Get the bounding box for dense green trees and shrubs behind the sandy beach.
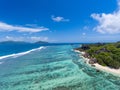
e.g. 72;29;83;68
77;42;120;69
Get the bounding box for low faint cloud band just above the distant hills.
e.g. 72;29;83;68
4;36;48;42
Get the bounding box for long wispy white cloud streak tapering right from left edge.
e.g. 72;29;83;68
0;22;49;33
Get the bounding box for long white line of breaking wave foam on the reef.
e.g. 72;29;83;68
0;46;45;60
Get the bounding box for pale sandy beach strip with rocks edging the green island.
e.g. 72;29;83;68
74;50;120;76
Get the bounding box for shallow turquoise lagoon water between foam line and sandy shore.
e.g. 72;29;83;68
0;45;120;90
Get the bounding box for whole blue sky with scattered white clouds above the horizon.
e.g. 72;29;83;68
0;0;120;43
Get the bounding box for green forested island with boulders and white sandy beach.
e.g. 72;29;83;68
75;42;120;74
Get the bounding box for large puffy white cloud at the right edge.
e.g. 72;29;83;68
91;0;120;34
